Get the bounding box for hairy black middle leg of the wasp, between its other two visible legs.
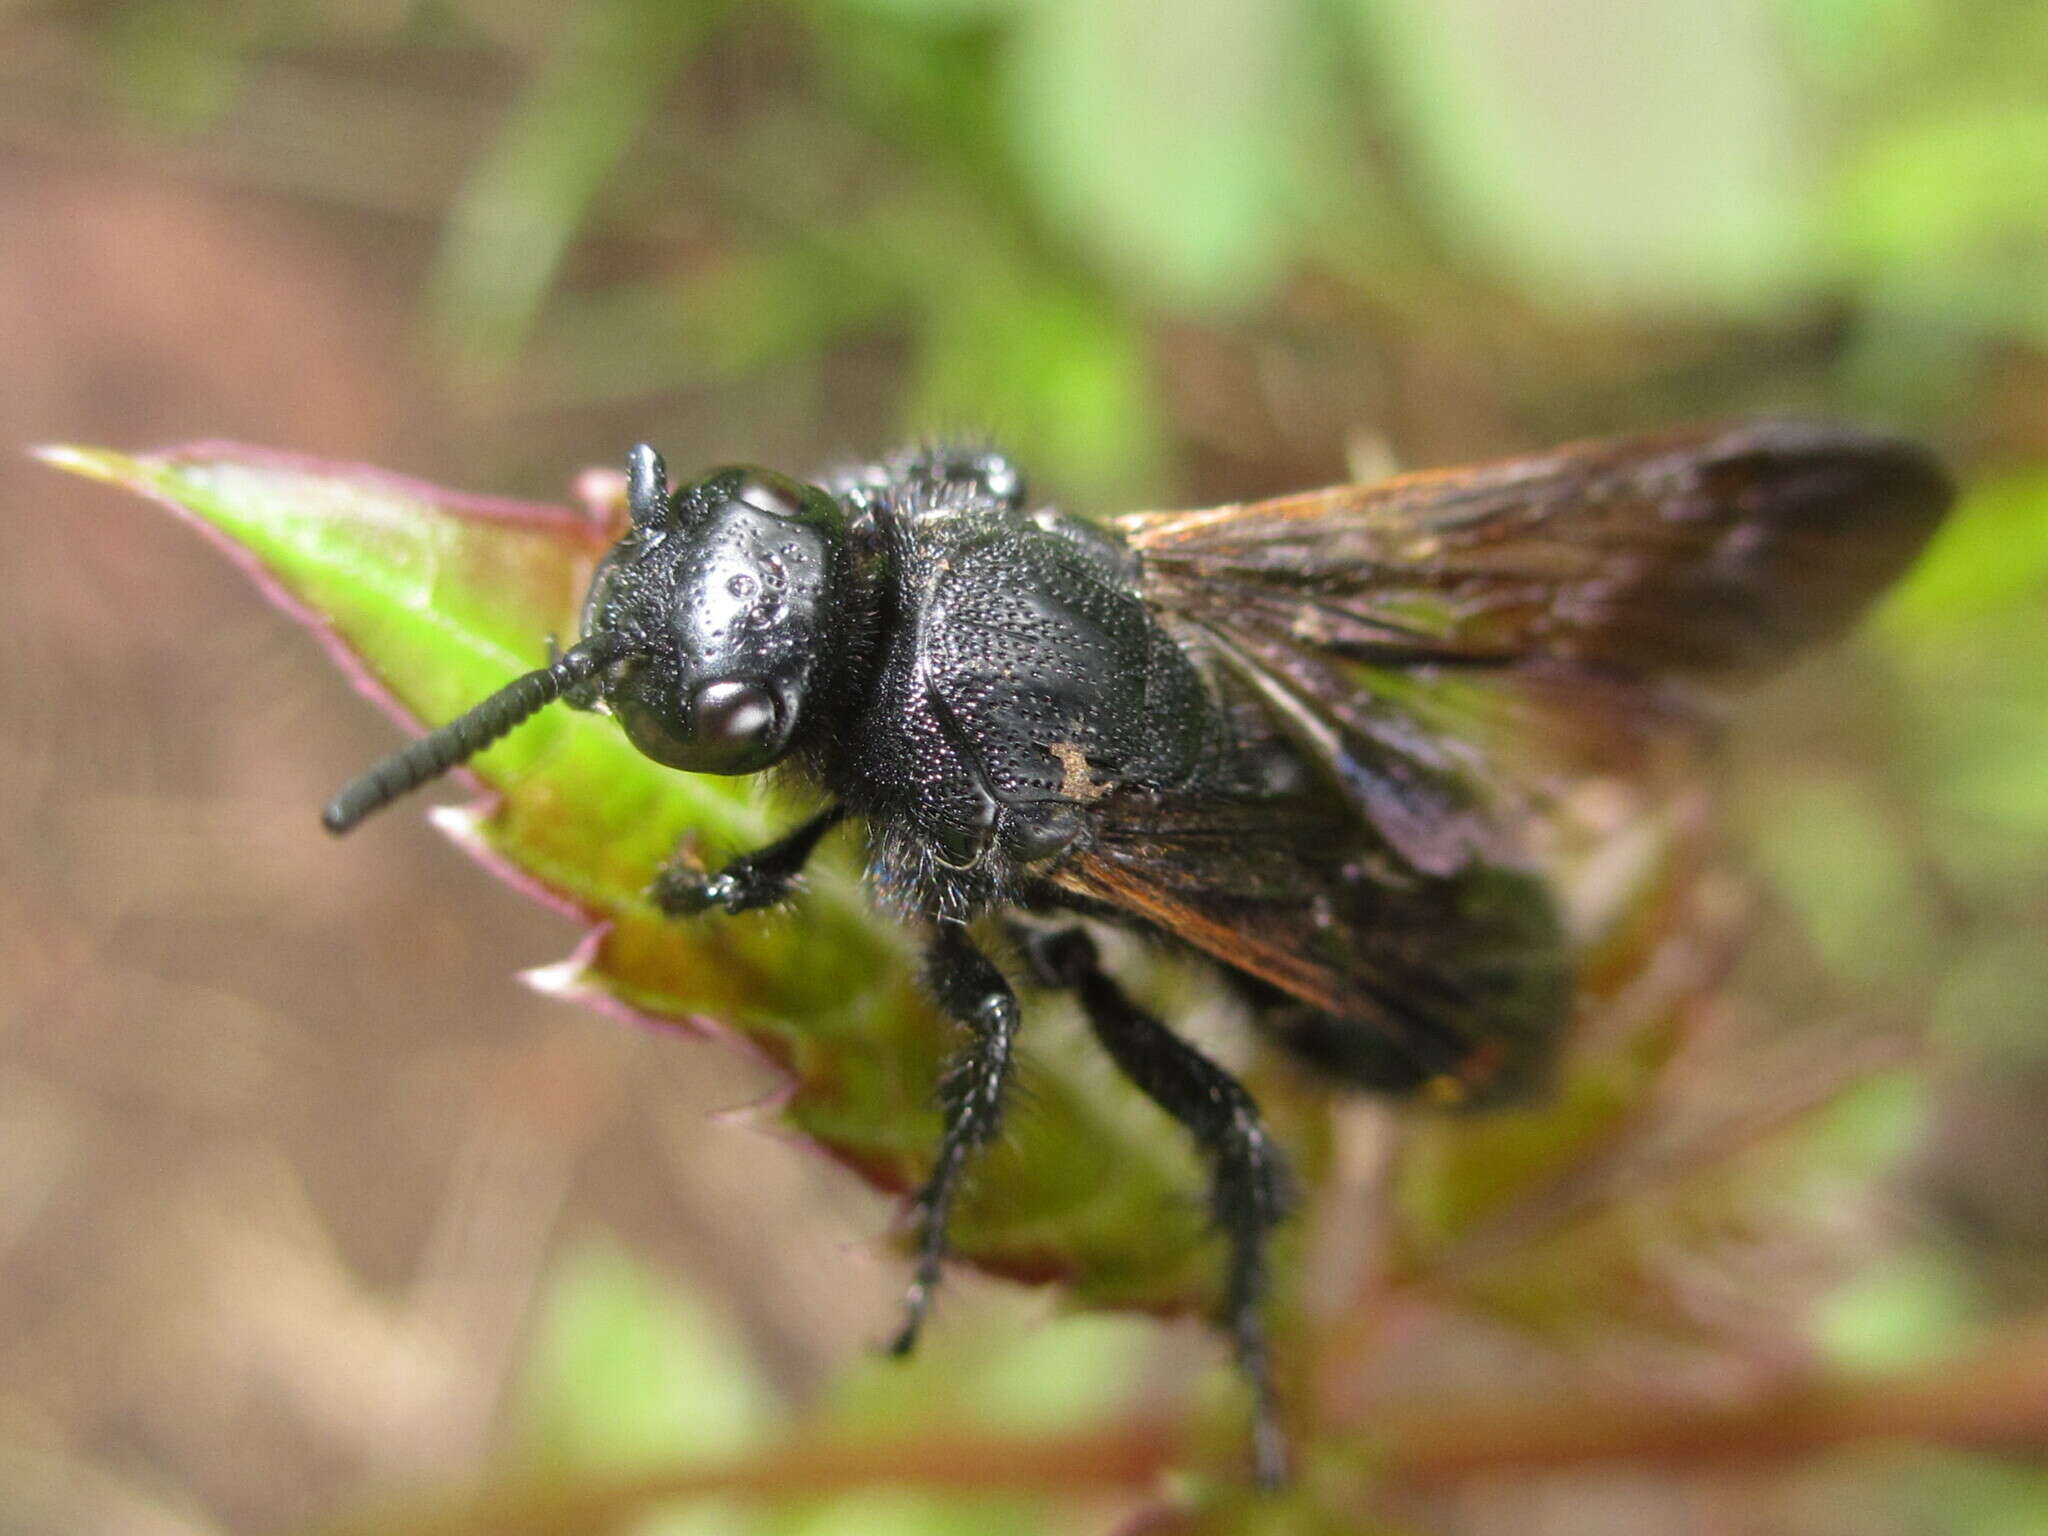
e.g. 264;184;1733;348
889;924;1018;1356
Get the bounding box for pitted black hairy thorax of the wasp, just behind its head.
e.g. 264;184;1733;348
819;487;1223;915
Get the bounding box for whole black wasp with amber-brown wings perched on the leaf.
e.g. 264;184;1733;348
326;422;1950;1479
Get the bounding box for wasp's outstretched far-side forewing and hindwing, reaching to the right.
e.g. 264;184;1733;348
1120;422;1950;874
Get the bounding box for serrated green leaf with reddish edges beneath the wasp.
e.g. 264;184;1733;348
43;444;1277;1307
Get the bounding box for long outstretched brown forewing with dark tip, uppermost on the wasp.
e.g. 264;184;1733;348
1118;422;1952;674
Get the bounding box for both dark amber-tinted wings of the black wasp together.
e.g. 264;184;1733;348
1055;422;1950;1100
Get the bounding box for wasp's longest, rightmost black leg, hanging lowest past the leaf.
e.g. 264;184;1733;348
1024;928;1294;1487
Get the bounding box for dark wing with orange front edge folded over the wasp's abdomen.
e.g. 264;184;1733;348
1053;786;1573;1106
